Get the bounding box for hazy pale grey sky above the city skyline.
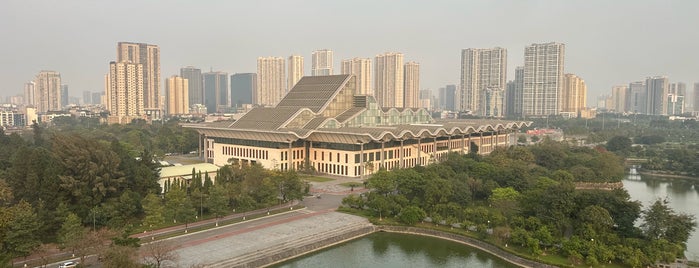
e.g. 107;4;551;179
0;0;699;106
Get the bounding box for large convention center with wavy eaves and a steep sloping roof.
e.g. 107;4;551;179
184;75;530;177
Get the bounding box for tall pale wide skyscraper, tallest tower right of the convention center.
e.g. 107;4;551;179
522;43;565;116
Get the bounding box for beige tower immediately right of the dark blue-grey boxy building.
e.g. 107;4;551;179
255;57;287;106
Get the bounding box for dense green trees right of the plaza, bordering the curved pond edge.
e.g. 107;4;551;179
343;140;696;267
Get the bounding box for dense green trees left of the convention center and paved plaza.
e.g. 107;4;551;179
0;118;307;267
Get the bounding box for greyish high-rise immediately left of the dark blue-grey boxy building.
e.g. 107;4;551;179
203;72;231;113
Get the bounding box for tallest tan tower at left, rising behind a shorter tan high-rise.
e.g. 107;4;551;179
116;42;162;109
